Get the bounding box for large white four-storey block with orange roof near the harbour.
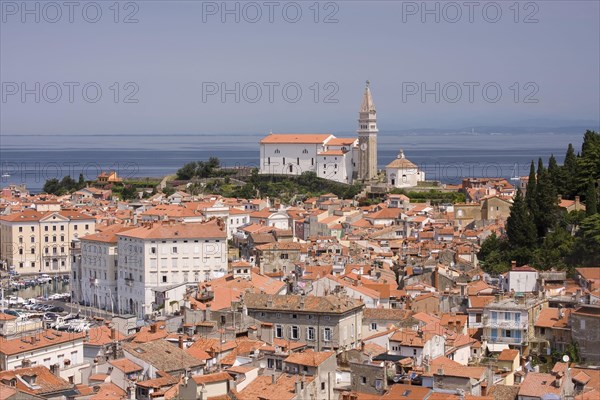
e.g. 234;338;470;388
117;219;227;317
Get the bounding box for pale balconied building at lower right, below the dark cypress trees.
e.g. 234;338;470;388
482;296;548;354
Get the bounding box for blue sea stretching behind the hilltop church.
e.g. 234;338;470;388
0;129;584;193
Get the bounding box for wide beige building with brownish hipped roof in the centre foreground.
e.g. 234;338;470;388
243;293;364;352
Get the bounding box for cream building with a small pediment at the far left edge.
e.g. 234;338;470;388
0;208;96;275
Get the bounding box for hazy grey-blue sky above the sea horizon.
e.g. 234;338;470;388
0;0;600;135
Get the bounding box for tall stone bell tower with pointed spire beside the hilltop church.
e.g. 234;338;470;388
356;81;379;181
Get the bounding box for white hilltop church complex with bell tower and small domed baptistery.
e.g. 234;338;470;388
259;81;425;187
